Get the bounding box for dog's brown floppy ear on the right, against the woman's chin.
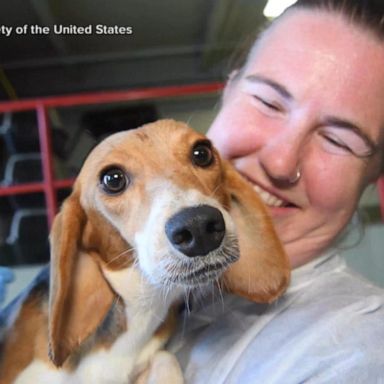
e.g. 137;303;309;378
223;162;290;303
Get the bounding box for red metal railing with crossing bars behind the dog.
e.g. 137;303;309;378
0;82;223;227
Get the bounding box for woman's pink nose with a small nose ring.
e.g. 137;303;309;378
258;134;304;184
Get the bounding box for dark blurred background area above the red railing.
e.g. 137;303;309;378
0;0;266;99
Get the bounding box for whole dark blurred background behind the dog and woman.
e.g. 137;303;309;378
0;0;384;306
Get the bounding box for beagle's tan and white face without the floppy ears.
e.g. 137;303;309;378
76;121;239;286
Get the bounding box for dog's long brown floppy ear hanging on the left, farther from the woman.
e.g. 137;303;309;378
49;192;114;366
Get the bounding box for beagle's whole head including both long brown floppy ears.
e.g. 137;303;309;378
49;120;289;365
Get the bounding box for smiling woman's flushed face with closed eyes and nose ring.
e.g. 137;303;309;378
208;10;384;267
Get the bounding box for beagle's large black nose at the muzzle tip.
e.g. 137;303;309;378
165;205;225;257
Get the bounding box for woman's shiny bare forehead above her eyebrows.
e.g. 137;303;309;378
243;10;384;141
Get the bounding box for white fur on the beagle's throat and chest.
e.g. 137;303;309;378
15;267;180;384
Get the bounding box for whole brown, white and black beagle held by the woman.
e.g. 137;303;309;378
0;120;290;384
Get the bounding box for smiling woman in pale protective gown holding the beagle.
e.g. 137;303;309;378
171;0;384;384
